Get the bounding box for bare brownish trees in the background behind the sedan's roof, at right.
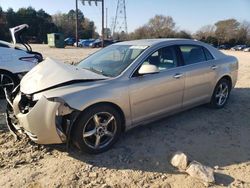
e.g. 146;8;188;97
125;15;250;46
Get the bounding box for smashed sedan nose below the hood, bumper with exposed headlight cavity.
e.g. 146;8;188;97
6;88;79;144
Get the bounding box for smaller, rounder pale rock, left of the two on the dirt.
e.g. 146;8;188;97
171;152;188;171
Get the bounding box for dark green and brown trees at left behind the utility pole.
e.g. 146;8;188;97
0;7;98;43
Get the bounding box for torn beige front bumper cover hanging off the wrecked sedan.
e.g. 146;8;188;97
6;93;63;144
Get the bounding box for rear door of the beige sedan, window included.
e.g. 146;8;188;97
179;45;216;108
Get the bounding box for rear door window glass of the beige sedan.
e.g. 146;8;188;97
180;45;206;65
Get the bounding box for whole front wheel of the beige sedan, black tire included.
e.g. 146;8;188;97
72;105;122;154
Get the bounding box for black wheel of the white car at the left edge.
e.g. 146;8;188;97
0;70;20;98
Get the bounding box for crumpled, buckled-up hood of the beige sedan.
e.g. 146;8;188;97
20;58;107;94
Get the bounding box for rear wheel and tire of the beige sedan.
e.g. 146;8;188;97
210;78;231;109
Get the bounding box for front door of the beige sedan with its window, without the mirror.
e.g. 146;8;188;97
129;46;185;124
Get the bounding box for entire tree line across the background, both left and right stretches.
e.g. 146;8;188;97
0;7;250;46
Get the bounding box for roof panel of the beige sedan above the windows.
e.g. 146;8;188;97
116;38;195;46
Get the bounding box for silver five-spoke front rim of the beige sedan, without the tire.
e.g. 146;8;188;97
83;112;117;149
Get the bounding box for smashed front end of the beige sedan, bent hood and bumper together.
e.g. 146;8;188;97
5;59;109;144
